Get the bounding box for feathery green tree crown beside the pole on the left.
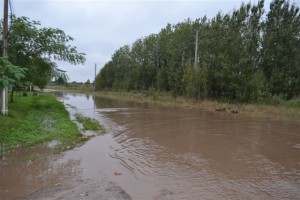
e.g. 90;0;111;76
0;16;85;92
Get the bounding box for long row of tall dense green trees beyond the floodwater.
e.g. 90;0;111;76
96;0;300;102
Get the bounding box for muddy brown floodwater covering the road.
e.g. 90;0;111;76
0;94;300;200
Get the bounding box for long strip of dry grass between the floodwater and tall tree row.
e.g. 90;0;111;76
45;90;300;121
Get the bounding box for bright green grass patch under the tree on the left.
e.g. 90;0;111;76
0;93;82;151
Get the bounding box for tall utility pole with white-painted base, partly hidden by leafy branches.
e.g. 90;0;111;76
1;0;8;115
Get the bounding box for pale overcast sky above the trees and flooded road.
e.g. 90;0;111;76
1;0;286;82
